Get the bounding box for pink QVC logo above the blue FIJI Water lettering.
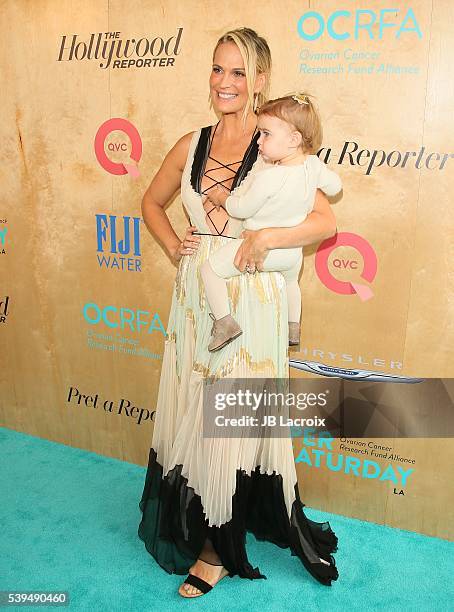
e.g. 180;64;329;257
94;117;142;178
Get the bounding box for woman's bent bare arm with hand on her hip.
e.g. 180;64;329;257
141;132;197;261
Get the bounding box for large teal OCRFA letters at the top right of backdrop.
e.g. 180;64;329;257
297;8;422;41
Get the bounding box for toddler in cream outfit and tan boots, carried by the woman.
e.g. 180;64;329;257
201;94;342;351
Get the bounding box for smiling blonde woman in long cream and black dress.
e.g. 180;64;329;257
139;28;337;597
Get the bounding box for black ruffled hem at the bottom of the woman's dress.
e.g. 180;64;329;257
138;448;338;585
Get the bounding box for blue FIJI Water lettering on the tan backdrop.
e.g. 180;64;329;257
95;214;143;272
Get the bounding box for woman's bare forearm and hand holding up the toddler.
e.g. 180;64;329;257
234;189;336;272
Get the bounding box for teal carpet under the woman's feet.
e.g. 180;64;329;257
0;428;454;612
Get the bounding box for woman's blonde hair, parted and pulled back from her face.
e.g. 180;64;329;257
210;28;271;123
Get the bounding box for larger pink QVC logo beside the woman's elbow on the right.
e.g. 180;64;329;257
315;232;377;302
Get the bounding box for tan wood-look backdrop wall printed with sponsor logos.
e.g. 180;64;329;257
0;0;454;539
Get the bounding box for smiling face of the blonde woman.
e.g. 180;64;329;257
210;41;252;114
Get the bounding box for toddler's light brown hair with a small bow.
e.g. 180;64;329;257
257;93;323;154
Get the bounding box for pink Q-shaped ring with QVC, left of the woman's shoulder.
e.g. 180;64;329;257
95;118;142;178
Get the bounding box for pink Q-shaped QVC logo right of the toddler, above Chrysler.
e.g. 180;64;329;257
315;232;377;302
